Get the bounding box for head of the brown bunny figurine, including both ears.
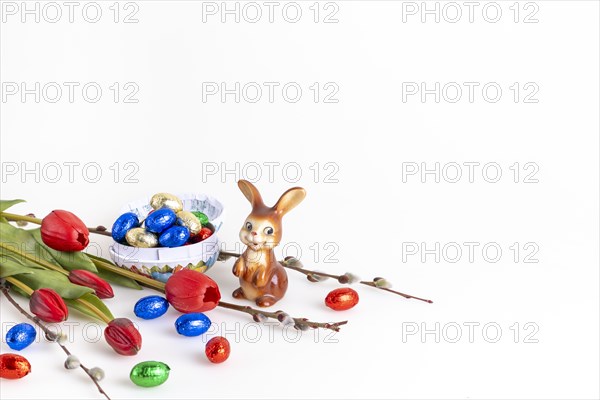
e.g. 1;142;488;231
238;180;306;251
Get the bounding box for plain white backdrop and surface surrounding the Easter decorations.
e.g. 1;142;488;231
0;1;600;399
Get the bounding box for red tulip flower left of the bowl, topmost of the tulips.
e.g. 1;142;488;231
41;210;90;251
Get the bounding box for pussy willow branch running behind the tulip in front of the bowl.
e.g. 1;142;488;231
88;254;348;332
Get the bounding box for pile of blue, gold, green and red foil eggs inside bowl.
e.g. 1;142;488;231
112;193;213;247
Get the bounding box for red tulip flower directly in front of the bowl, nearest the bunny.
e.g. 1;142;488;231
165;268;221;313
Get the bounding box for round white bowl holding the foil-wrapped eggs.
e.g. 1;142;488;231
109;193;223;282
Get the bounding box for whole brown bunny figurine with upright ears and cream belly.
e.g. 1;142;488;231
233;180;306;307
